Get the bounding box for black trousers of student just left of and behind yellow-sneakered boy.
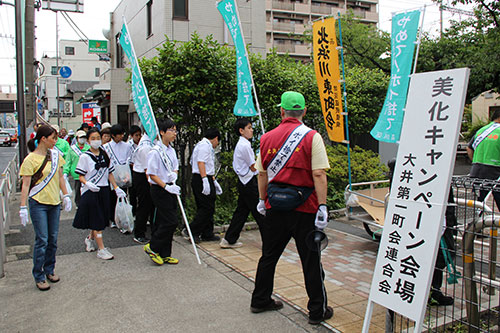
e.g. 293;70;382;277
130;171;154;238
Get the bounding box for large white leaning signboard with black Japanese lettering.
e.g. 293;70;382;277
363;68;469;332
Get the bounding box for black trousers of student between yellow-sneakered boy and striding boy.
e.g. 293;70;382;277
189;173;216;238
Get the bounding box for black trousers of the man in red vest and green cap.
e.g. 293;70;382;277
251;209;327;319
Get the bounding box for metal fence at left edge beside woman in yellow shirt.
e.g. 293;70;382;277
0;154;19;278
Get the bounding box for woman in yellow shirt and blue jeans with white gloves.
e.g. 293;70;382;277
19;125;71;290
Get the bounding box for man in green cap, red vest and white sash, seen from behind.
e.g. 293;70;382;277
250;91;333;325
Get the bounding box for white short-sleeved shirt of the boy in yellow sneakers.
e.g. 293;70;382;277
147;142;179;185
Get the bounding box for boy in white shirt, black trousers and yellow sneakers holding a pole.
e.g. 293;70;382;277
144;119;181;265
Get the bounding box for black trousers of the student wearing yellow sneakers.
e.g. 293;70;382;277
149;185;178;258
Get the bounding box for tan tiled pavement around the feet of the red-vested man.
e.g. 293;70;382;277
200;224;385;332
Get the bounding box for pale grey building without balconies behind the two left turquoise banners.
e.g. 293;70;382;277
101;0;266;128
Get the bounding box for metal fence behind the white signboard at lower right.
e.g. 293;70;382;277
386;177;500;332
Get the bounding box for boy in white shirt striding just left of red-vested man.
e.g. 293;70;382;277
220;118;264;249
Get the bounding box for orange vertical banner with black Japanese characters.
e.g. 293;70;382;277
313;17;345;142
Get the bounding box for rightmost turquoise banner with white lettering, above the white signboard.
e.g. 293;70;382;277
370;10;420;142
